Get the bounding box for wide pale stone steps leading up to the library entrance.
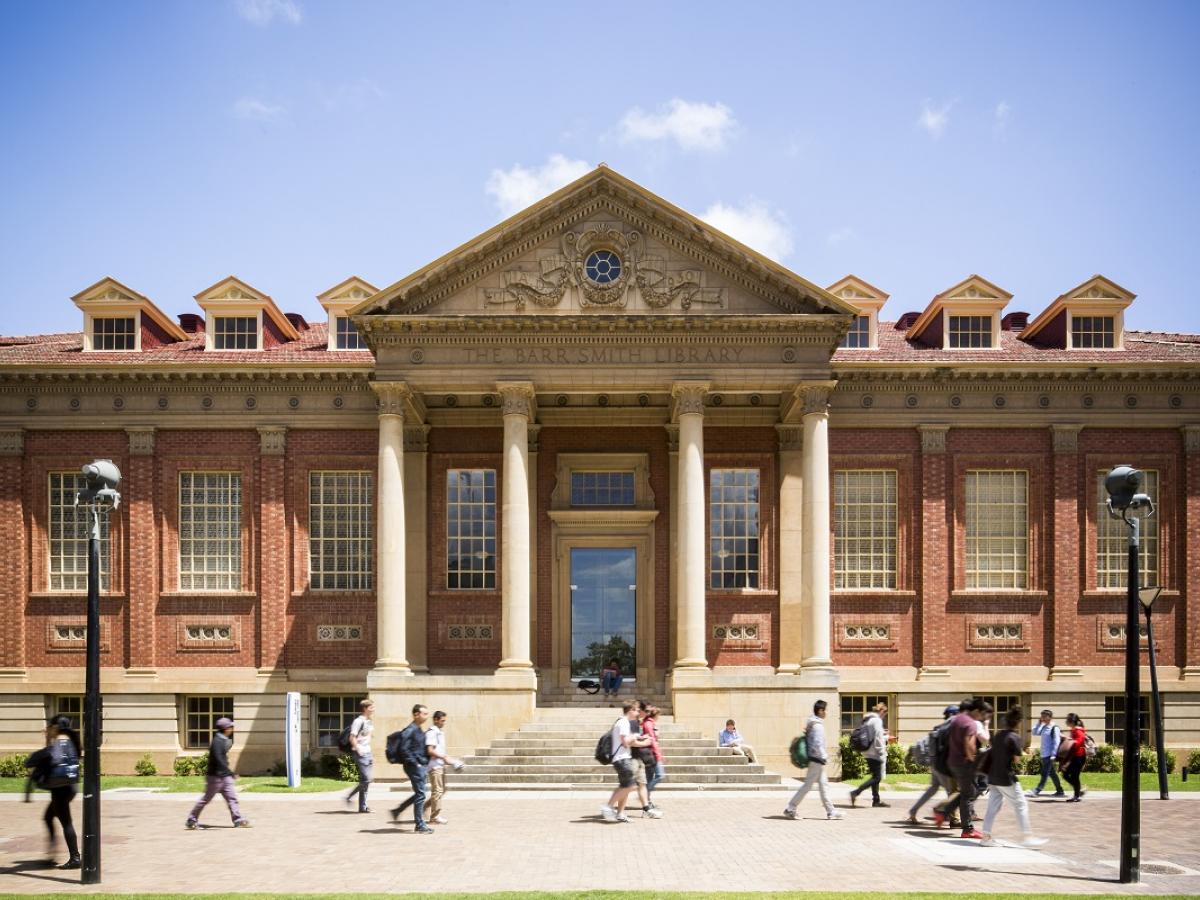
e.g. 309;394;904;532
450;697;786;791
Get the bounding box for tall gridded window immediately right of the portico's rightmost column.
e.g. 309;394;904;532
833;469;896;589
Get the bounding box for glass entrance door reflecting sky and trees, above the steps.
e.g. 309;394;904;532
570;547;637;678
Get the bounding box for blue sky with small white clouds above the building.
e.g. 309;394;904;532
0;0;1200;335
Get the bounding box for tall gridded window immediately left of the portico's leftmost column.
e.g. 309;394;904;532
308;472;373;590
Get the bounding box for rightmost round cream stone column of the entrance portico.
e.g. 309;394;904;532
799;383;834;680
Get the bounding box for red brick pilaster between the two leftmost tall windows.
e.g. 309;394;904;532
121;426;158;676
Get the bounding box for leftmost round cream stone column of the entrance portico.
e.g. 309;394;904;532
371;382;413;674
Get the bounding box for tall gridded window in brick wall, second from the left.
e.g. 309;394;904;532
179;472;241;590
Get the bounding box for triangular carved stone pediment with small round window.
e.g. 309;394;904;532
350;166;857;316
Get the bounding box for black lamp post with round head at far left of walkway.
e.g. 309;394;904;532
76;460;121;884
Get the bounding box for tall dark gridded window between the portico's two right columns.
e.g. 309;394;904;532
708;469;758;589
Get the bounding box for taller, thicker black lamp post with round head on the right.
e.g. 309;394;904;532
1104;466;1154;884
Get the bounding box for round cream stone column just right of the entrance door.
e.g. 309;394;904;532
671;382;709;668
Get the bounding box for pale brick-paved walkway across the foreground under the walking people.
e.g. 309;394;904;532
0;785;1200;894
